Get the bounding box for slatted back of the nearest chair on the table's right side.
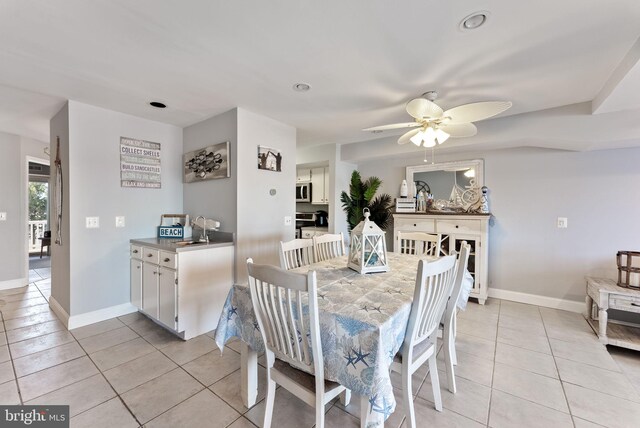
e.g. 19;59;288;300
405;256;456;348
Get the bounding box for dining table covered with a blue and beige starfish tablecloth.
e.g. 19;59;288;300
215;252;473;428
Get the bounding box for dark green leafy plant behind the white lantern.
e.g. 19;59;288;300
340;171;393;230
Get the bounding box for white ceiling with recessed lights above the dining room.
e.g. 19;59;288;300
0;0;640;154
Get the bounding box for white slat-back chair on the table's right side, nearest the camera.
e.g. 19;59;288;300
391;252;456;428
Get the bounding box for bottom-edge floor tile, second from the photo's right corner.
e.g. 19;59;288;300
489;389;573;428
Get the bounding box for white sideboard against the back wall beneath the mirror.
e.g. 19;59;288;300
393;213;491;305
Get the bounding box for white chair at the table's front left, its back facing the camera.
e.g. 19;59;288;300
247;259;350;428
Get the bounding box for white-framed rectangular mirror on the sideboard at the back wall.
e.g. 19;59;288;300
407;159;484;212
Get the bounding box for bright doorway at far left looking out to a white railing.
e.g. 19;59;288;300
27;159;51;283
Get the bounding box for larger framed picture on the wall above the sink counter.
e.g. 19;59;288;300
182;141;231;183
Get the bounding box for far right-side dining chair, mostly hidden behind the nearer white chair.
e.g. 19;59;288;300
442;241;471;394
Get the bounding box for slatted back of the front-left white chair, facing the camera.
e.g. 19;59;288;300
247;259;323;375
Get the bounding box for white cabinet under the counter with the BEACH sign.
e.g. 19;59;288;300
130;239;234;340
